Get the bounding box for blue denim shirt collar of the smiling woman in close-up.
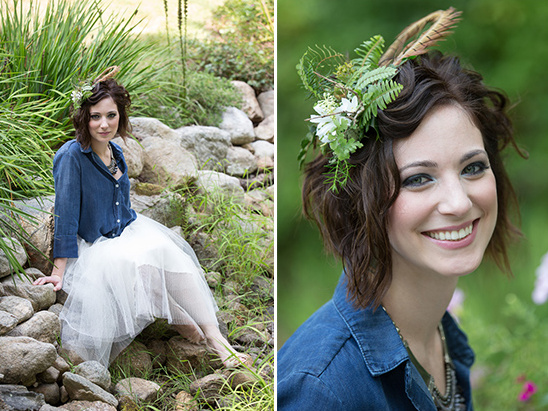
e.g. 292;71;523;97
333;272;474;376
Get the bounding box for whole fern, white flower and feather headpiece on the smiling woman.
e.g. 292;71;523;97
297;7;461;192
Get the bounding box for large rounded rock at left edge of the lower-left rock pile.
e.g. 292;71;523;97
0;337;57;384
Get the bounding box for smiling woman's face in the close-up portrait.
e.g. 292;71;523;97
388;105;497;282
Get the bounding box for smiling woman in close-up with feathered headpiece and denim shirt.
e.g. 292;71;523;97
278;9;519;411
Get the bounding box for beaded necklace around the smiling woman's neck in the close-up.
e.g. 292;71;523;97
382;306;466;411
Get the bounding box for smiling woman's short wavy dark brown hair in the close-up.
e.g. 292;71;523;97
302;52;526;308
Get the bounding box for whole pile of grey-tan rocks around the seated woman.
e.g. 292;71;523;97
0;82;274;411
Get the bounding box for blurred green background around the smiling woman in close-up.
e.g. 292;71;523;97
276;0;548;410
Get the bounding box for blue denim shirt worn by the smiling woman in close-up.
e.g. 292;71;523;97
277;273;474;411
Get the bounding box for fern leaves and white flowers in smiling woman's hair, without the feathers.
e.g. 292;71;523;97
297;36;403;192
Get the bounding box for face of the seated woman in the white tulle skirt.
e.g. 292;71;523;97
89;97;120;144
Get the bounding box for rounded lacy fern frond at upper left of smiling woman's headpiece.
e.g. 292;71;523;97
297;46;346;99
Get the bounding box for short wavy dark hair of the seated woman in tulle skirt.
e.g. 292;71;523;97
72;79;131;148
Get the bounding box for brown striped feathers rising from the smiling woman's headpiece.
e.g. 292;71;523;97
379;7;462;66
